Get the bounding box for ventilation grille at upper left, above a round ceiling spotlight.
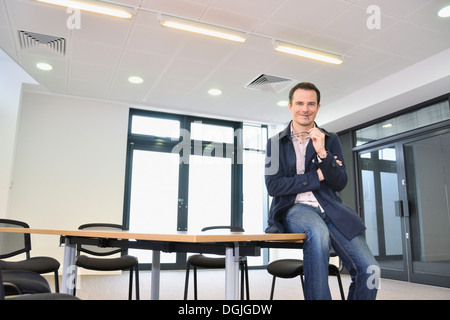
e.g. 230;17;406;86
19;31;66;55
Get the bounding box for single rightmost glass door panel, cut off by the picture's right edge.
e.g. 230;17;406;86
403;133;450;286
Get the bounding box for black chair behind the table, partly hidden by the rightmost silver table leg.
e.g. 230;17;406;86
184;226;250;300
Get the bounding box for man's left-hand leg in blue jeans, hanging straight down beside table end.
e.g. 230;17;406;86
282;203;331;300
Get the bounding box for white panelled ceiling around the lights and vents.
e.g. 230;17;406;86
0;0;450;131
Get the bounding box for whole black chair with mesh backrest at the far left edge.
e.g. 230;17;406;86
0;219;60;292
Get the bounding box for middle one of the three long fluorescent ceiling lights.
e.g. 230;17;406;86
161;16;247;42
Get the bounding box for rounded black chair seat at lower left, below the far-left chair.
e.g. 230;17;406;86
2;270;50;294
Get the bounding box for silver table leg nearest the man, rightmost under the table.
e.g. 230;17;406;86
225;246;239;300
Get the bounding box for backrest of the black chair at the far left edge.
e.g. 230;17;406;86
0;219;31;259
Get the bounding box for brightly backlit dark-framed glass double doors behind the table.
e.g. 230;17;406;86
124;111;242;268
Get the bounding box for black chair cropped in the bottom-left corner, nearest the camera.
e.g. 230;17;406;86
0;262;79;300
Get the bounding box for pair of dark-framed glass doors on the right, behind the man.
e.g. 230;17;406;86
358;131;450;287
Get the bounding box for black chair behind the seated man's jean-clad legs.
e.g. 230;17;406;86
267;253;345;300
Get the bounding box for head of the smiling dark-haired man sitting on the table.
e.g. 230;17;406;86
289;82;320;132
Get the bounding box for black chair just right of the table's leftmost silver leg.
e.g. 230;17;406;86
74;223;139;300
